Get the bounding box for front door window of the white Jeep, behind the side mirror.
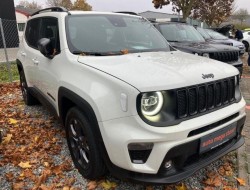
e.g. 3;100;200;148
39;17;60;54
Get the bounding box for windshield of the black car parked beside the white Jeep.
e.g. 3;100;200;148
160;23;205;42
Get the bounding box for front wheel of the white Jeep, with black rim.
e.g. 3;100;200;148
65;107;106;179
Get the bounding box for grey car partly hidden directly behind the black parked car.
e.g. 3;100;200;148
196;27;245;55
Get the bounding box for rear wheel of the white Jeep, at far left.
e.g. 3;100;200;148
19;70;39;106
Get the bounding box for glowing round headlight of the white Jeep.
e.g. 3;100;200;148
141;92;163;116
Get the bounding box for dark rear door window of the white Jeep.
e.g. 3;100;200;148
25;19;40;49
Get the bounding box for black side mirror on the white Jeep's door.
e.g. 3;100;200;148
37;38;54;59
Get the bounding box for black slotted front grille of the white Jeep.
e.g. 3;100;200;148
176;77;235;118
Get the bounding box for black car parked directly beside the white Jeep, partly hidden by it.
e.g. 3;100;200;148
153;22;243;73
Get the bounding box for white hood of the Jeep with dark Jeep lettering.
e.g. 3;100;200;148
78;51;238;92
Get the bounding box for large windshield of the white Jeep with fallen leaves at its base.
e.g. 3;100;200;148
66;14;170;55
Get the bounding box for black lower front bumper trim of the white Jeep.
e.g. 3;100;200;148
111;134;244;184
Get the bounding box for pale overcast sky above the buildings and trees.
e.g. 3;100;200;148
14;0;250;13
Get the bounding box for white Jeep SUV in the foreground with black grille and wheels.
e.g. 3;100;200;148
17;7;246;183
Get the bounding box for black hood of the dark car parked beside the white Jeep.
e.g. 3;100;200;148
170;42;238;53
